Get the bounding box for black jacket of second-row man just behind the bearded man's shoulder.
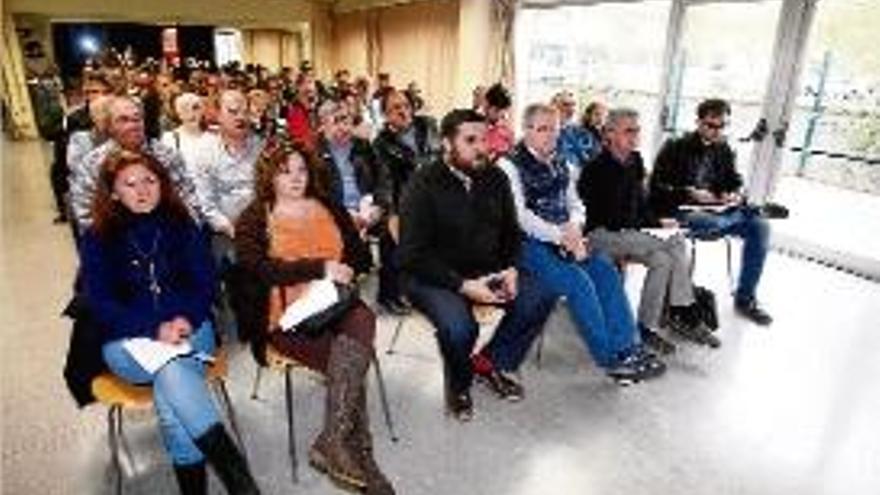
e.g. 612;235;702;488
373;115;441;214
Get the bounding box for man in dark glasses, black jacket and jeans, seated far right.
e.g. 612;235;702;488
650;99;772;325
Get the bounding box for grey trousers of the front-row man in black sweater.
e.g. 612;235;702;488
589;228;694;329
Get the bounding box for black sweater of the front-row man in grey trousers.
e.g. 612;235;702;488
577;148;659;230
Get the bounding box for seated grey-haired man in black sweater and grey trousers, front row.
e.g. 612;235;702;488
578;108;721;353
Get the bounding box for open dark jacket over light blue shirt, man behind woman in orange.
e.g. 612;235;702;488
318;137;388;209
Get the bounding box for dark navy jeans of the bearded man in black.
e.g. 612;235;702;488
407;272;556;393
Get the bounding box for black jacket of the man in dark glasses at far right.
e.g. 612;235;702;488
650;132;743;216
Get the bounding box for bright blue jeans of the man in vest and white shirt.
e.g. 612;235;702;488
520;239;637;368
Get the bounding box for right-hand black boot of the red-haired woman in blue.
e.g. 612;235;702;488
195;423;260;495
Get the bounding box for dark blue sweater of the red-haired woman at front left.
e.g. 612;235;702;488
81;210;215;342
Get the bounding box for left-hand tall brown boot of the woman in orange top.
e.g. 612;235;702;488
309;335;370;490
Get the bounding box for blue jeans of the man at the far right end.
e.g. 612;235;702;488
681;207;770;302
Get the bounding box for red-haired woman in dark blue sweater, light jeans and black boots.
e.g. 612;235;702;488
82;150;259;495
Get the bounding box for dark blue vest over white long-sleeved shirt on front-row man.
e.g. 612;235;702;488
510;143;569;225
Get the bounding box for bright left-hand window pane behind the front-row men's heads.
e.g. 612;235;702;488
516;0;671;156
